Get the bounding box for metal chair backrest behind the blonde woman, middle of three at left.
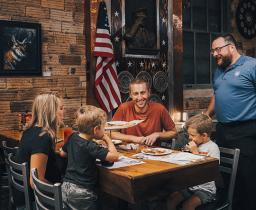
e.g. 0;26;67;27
8;153;32;210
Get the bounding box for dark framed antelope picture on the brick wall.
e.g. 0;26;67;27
0;20;42;76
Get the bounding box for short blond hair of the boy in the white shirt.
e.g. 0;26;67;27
186;114;213;136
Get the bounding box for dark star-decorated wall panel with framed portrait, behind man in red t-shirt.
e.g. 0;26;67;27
110;0;171;107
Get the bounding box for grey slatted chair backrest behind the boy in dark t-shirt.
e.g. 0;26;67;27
31;168;63;210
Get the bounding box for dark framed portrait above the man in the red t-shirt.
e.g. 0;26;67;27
122;0;160;58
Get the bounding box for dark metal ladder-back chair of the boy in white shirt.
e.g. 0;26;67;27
197;147;240;210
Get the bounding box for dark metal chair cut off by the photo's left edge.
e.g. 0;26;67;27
1;141;18;209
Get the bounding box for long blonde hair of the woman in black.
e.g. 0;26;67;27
29;94;60;140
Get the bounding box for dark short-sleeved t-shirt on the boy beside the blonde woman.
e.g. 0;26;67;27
62;133;108;190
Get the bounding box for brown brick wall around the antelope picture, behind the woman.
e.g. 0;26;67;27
0;0;86;136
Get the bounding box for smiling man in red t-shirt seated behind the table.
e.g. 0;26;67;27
111;79;177;145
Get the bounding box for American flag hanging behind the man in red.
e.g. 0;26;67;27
94;2;121;112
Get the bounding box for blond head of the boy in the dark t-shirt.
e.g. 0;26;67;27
76;105;107;135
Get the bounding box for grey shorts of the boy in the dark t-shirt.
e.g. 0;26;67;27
61;182;98;210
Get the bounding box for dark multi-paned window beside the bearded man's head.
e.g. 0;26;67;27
182;0;230;87
